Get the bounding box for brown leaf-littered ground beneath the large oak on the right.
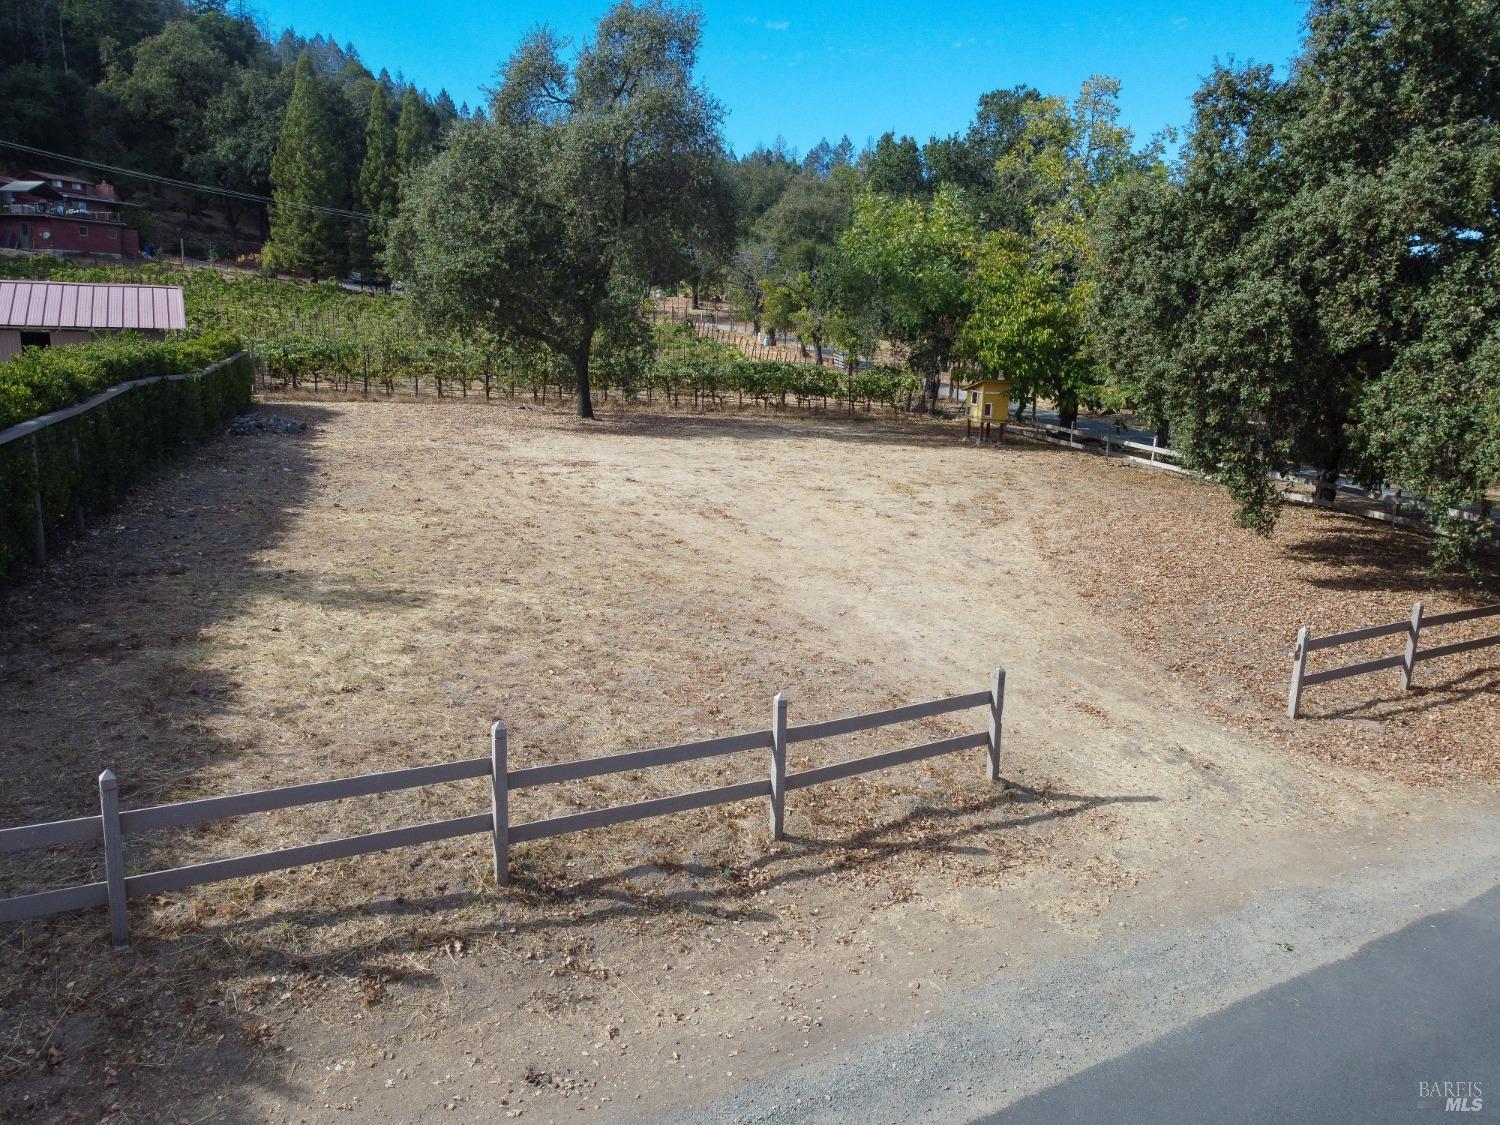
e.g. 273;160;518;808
1032;456;1500;785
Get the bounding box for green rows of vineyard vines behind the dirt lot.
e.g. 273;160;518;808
3;260;921;413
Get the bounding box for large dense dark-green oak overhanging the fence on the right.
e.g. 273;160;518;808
1091;0;1500;561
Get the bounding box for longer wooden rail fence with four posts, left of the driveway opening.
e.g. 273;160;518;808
0;669;1005;948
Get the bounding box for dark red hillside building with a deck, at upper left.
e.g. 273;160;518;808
0;170;141;258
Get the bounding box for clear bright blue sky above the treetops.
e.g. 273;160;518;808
260;0;1305;153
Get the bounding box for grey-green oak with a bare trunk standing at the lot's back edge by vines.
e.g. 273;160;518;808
389;0;723;417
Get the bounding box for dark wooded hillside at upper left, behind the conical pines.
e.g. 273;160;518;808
0;0;483;258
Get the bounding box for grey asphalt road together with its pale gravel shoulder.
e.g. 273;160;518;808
668;813;1500;1125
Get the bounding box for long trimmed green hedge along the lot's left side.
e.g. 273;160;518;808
0;338;255;581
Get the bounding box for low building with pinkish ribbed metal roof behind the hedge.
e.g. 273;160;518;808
0;281;188;363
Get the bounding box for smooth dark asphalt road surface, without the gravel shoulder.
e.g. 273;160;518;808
981;887;1500;1125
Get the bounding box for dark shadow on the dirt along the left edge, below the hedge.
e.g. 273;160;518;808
0;405;343;1121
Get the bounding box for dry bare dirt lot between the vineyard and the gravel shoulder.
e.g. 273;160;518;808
0;402;1500;1122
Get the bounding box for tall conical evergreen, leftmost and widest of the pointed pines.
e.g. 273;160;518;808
266;51;347;275
